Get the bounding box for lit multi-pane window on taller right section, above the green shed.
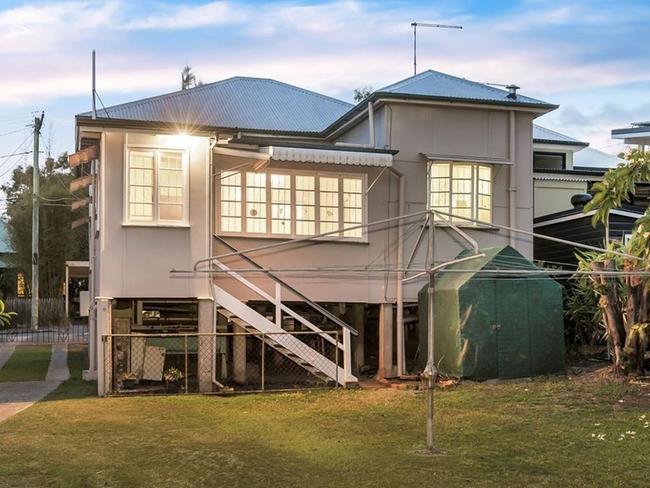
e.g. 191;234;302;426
429;161;492;224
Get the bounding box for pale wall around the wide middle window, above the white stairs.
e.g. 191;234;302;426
213;155;398;303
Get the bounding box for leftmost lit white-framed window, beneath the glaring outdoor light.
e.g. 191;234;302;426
124;147;189;225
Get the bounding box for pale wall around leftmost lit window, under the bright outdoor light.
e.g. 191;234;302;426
95;131;211;298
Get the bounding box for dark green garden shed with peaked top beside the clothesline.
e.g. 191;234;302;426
418;246;564;379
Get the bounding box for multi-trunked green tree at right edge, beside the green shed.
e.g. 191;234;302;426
581;149;650;373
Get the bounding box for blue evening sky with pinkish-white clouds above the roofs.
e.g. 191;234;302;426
0;0;650;187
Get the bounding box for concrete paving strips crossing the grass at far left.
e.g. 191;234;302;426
0;344;70;422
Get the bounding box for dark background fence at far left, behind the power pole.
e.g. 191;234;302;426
0;298;88;344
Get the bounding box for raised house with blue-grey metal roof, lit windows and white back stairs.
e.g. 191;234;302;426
76;71;556;394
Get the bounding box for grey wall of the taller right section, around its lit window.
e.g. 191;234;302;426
334;103;533;301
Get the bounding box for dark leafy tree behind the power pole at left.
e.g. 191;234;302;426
1;154;88;297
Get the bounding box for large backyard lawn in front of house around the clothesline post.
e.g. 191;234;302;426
0;350;650;488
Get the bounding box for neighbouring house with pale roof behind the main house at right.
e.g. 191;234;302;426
533;124;625;218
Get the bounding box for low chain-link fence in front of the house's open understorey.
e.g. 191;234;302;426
102;331;345;394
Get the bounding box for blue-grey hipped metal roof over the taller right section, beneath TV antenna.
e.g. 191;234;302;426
377;70;556;108
